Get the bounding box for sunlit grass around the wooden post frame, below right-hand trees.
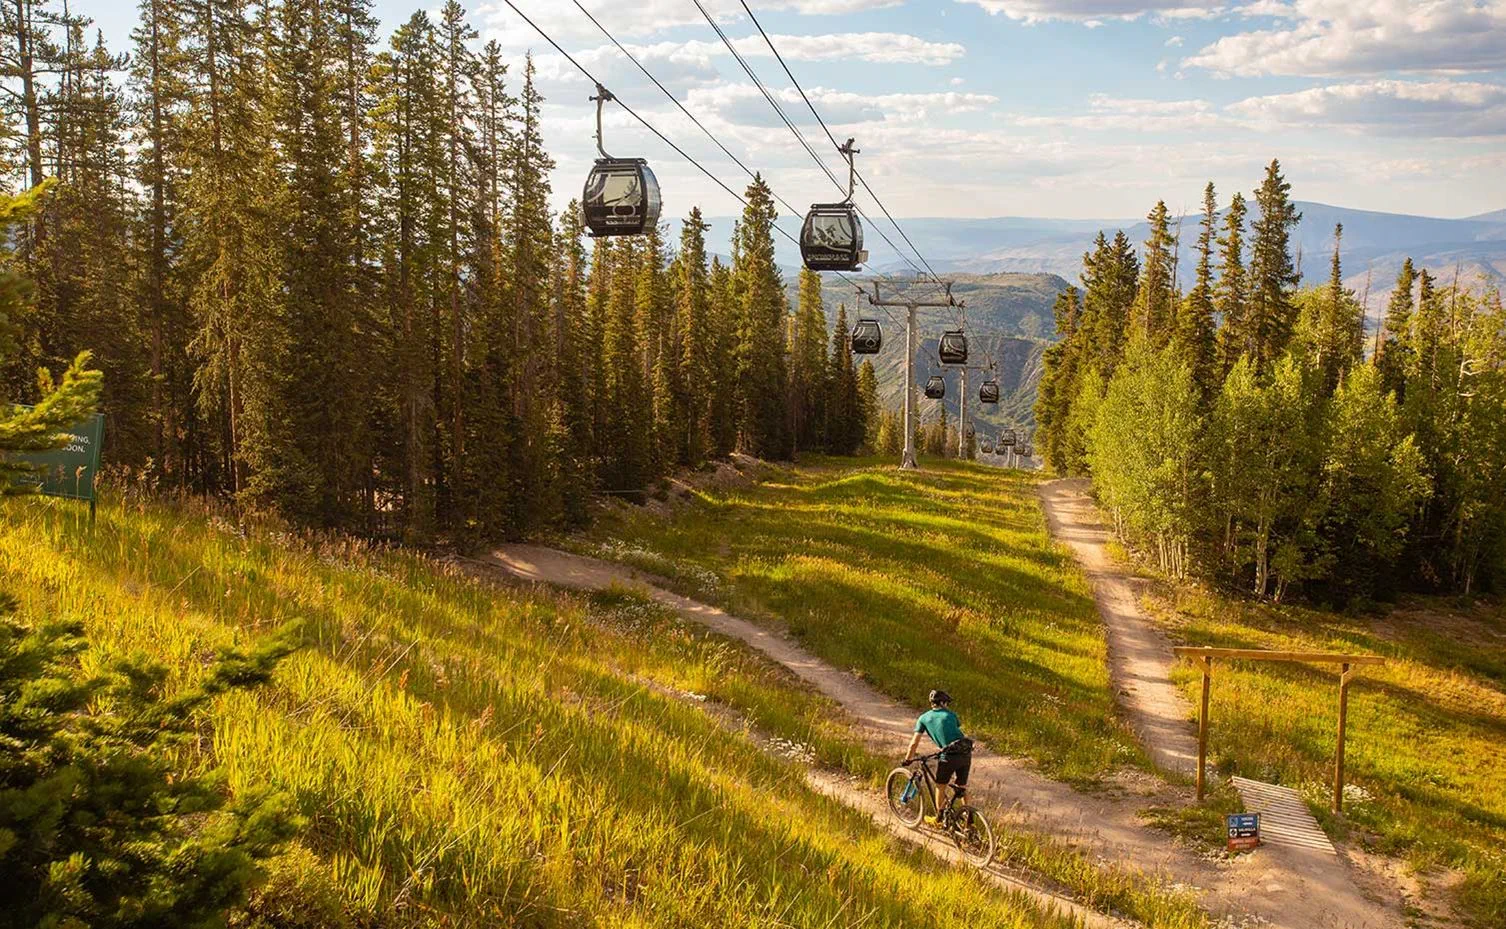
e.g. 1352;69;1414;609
1149;589;1506;927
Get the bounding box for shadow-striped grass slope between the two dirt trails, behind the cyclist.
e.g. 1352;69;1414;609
575;459;1142;780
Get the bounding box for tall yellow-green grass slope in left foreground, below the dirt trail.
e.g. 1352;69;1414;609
0;498;1078;929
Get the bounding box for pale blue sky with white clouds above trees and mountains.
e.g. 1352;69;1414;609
72;0;1506;218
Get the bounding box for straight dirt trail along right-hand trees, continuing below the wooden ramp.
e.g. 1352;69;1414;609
1041;480;1401;927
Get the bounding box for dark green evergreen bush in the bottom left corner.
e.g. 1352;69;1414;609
0;595;297;929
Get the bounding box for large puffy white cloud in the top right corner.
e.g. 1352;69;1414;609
1182;0;1506;77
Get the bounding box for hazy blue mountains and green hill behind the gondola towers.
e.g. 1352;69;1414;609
711;202;1506;432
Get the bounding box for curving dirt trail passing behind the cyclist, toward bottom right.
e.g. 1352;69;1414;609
485;545;1402;929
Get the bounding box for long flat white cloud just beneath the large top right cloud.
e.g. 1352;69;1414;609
1227;80;1506;139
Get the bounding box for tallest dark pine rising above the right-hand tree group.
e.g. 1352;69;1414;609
1245;160;1303;372
